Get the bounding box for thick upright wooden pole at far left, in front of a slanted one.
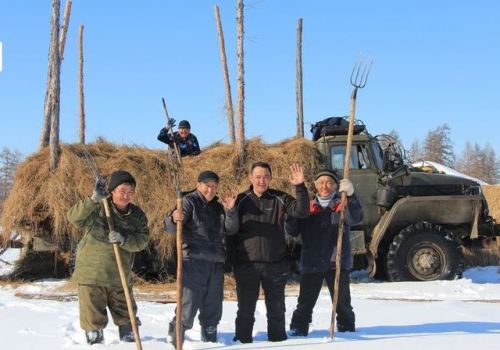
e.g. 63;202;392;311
48;0;61;172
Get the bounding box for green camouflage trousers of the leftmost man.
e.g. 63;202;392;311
78;284;137;331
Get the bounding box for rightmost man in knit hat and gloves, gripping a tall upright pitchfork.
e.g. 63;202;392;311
285;170;363;336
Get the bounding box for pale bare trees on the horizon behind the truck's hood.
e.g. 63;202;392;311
389;123;500;184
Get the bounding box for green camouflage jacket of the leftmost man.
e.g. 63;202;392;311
67;198;149;288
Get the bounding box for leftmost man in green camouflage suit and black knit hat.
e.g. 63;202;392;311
67;170;149;344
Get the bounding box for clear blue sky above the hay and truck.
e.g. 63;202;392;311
0;0;500;155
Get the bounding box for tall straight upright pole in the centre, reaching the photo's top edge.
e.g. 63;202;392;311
236;0;245;167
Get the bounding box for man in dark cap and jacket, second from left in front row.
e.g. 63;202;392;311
165;170;238;347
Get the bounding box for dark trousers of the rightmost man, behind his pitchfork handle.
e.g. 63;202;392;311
290;270;355;333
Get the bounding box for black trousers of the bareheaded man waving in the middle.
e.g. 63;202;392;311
234;261;287;343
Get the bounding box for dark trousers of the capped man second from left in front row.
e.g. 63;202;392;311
170;259;224;330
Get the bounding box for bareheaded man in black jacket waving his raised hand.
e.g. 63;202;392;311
232;162;309;343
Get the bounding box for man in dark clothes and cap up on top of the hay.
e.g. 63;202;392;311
158;119;200;157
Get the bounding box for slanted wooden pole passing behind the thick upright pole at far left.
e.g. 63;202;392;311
39;0;72;149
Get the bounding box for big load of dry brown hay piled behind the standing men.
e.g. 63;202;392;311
1;139;320;259
